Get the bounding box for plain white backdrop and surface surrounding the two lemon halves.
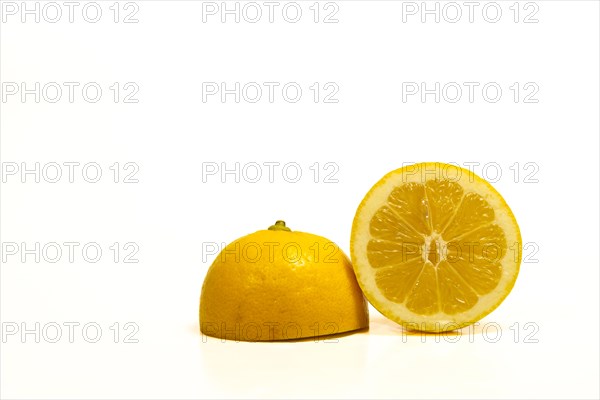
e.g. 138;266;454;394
0;1;600;399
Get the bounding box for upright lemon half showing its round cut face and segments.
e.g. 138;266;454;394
350;163;521;332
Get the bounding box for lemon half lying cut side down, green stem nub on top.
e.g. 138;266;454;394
200;221;369;341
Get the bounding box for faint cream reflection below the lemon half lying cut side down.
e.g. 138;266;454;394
197;327;369;398
